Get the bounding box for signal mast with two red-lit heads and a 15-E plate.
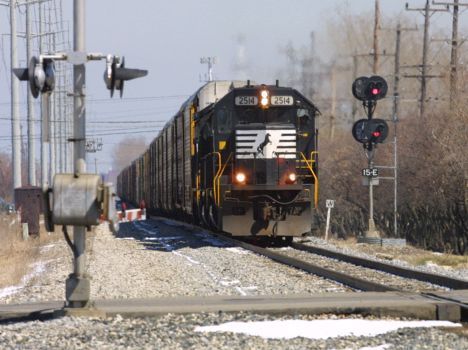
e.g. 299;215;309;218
352;75;388;244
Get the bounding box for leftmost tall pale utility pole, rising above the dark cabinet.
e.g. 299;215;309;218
10;0;21;188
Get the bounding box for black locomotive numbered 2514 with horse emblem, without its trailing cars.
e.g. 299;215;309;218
193;85;318;236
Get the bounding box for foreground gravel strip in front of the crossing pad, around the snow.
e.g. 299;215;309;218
0;313;468;350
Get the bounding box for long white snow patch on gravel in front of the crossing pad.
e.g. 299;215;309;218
195;319;462;339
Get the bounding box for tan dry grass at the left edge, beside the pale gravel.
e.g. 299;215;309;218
0;215;62;288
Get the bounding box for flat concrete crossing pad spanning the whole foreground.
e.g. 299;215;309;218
0;291;468;322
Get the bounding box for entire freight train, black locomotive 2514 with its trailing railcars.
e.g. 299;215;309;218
117;81;319;240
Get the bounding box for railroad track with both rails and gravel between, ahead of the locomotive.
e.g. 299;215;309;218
141;217;468;293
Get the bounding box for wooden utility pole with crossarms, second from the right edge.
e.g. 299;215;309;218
406;0;448;119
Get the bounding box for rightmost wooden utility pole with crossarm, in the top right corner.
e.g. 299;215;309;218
432;0;468;108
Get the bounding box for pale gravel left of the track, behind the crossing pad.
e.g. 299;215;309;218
0;219;349;303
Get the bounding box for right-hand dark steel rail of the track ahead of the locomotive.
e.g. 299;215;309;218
291;243;468;289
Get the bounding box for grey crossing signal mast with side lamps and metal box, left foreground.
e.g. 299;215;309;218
13;0;148;309
